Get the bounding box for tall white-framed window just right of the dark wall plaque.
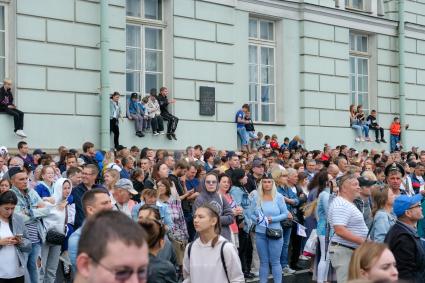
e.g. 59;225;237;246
248;18;276;122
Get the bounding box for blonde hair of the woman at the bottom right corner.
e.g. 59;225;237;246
348;242;388;280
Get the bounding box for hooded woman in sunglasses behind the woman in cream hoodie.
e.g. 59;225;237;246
193;172;234;241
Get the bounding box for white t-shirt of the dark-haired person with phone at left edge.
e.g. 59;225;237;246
0;220;24;279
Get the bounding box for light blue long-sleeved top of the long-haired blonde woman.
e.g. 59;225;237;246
251;194;288;234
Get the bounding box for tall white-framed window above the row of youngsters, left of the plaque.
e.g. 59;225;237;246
126;0;164;102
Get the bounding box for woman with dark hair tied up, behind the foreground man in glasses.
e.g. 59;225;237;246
139;219;177;283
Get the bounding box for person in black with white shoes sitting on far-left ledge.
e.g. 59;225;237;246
0;79;27;138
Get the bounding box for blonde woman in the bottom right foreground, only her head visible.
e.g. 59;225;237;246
348;242;398;282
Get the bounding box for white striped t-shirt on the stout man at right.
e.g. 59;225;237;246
328;196;368;248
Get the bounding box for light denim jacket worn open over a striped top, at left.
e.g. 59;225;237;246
11;187;52;242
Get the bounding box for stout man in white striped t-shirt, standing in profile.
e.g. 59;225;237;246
328;174;368;283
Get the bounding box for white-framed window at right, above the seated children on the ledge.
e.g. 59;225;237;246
350;33;370;111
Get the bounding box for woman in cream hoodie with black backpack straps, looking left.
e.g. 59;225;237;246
183;204;245;283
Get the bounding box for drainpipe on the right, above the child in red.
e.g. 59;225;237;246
398;0;407;146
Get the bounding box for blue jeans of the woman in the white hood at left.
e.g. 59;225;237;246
41;243;61;283
